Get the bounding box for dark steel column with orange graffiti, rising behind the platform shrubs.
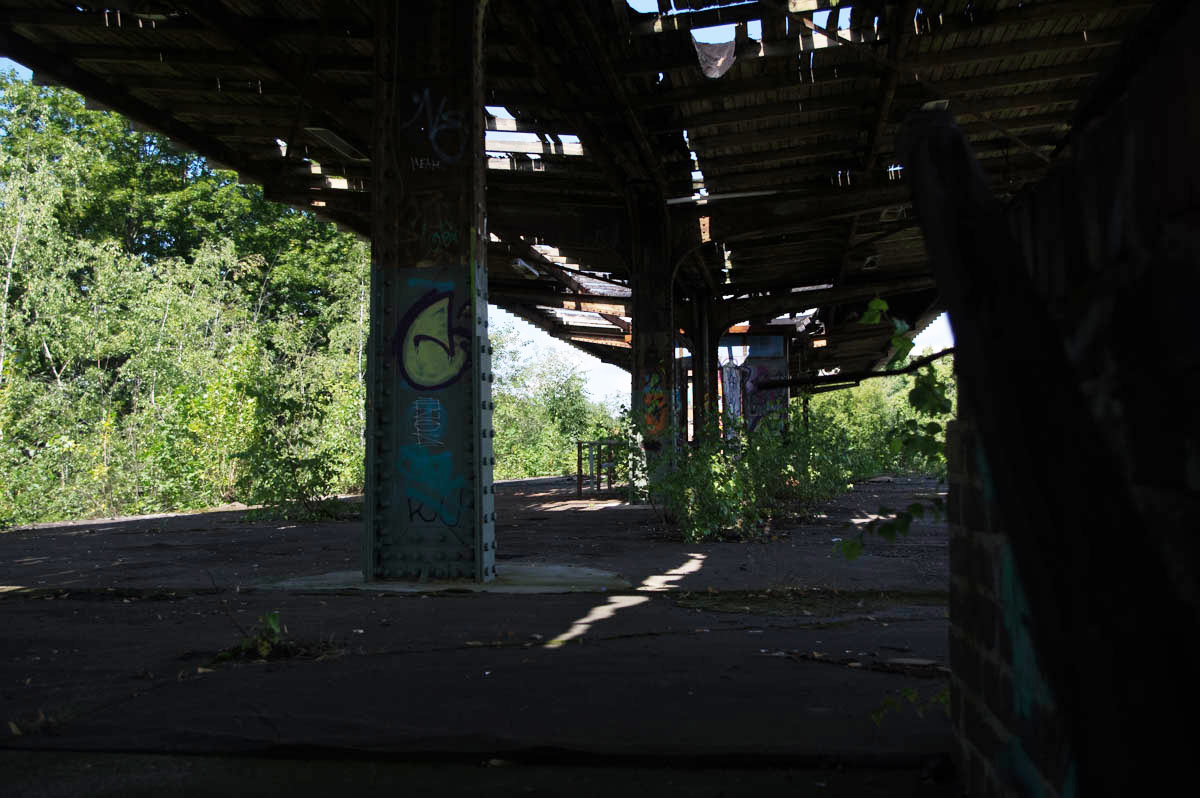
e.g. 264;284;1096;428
629;187;678;460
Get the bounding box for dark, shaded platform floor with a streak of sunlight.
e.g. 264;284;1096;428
0;478;955;796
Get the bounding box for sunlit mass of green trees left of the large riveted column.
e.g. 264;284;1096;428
0;73;367;522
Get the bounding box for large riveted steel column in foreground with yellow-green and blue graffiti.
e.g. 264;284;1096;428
362;0;496;581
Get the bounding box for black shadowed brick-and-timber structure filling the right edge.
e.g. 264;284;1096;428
899;1;1200;796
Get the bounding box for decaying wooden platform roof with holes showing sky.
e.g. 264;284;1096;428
0;0;1151;372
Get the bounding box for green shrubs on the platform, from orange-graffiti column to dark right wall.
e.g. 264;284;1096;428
625;355;953;541
